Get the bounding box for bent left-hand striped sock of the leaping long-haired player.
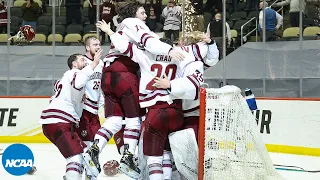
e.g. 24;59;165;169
94;116;122;153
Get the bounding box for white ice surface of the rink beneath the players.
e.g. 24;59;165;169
0;144;320;180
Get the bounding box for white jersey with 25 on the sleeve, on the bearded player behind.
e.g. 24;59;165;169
84;56;104;114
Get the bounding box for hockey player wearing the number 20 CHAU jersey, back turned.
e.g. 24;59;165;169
101;20;219;179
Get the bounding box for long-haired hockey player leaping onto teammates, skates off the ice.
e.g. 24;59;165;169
88;1;183;177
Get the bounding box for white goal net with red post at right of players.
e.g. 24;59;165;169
198;86;284;180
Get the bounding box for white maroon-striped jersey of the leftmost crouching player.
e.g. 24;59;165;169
39;66;94;124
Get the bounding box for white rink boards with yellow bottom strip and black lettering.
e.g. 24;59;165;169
0;96;320;156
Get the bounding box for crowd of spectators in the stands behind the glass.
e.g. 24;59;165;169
0;0;320;47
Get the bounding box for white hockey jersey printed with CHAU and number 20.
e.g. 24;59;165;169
110;33;217;107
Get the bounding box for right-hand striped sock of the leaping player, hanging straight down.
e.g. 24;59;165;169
123;117;140;154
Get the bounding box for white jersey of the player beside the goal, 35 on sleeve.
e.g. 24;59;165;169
166;43;219;117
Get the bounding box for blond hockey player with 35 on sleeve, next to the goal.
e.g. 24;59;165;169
155;32;219;179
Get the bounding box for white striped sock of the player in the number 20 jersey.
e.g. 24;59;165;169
147;156;163;180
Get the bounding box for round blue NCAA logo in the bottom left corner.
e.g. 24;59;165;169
2;144;34;176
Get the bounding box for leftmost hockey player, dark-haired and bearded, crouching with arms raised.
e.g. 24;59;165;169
39;49;102;180
